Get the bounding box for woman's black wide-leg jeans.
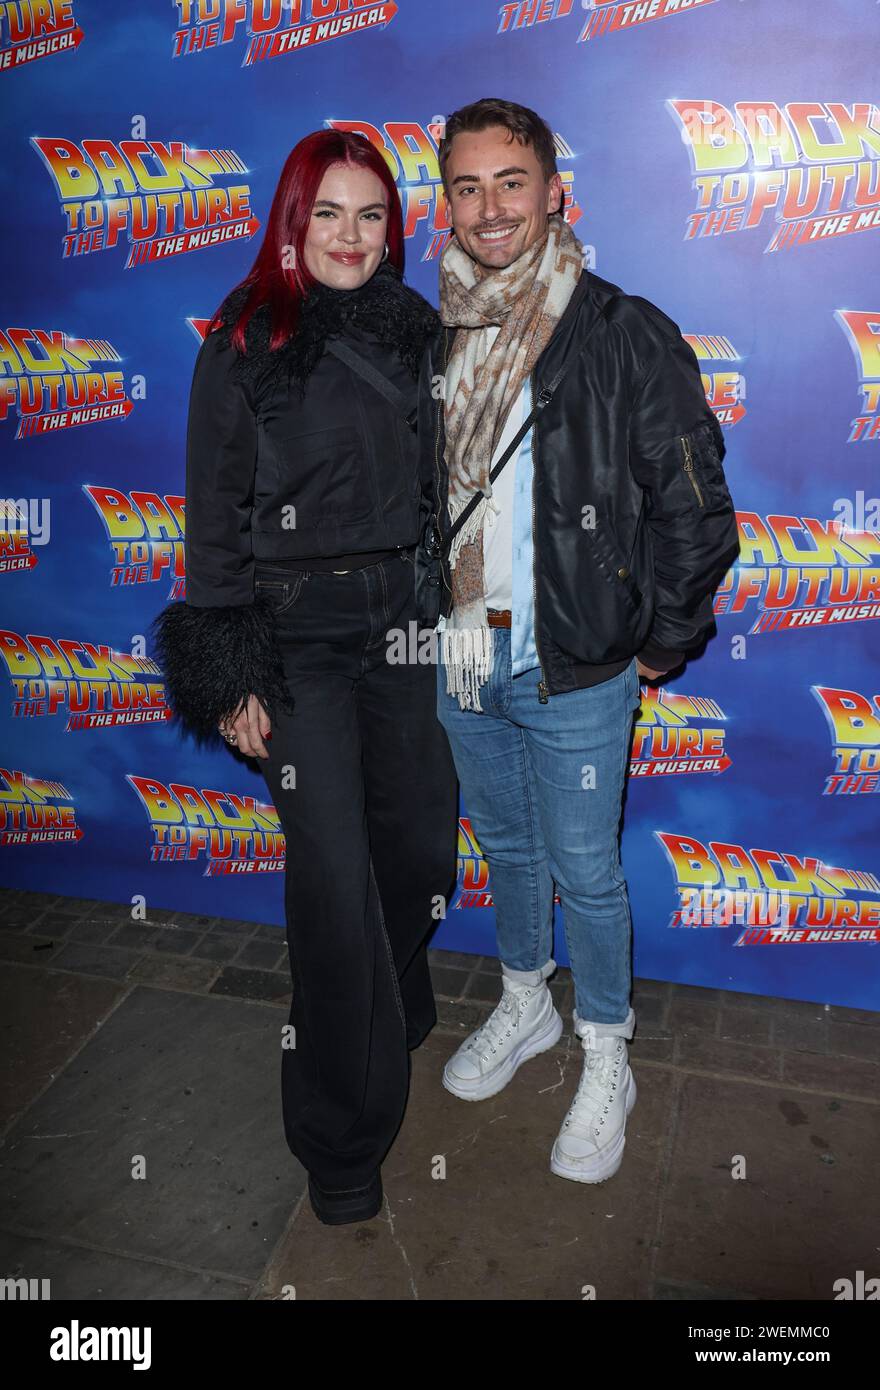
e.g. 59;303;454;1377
256;550;457;1190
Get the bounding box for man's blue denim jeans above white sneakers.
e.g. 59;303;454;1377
437;628;639;1023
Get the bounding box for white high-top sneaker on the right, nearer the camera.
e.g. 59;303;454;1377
551;1009;635;1183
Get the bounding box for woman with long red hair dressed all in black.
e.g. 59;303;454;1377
154;131;457;1223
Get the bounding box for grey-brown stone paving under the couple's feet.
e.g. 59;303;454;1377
0;891;880;1301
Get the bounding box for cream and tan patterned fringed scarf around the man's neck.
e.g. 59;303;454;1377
439;213;584;710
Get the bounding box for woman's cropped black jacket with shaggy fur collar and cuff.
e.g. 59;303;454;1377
153;263;438;742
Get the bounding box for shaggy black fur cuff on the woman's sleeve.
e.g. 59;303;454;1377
152;595;293;744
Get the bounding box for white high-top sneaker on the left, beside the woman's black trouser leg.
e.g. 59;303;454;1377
443;960;562;1101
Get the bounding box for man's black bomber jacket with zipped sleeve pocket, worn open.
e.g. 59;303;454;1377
418;270;740;701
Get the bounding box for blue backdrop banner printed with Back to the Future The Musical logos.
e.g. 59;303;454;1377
0;0;880;1008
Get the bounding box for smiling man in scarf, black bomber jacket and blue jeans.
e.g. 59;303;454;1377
418;99;738;1183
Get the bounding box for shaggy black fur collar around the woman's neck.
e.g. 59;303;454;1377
217;261;439;403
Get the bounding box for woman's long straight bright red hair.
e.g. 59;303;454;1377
207;129;403;353
